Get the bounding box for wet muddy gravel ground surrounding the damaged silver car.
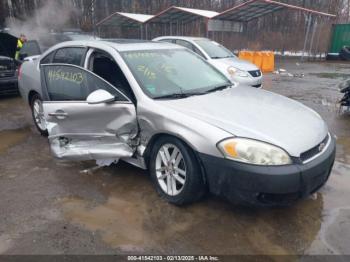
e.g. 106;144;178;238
0;60;350;255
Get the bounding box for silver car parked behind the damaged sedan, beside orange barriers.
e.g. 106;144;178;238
153;36;263;88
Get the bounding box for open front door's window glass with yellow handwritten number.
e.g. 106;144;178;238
42;64;128;101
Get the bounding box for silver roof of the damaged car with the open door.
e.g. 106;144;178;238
46;39;185;52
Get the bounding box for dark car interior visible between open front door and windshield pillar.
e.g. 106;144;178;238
89;52;136;103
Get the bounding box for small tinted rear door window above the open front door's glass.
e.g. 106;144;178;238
52;47;86;66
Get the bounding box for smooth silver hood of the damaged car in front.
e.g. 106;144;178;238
161;86;328;157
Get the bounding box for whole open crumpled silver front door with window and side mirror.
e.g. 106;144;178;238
41;64;138;163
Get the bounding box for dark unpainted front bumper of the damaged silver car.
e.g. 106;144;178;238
199;137;336;206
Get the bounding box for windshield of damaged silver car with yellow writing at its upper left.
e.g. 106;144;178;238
122;49;232;98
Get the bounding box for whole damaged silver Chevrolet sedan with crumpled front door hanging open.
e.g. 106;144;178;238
19;41;335;206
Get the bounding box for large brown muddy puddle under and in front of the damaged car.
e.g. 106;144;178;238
60;165;323;255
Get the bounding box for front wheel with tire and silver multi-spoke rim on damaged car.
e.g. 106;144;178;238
149;137;205;206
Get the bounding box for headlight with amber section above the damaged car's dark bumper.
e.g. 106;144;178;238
218;138;292;166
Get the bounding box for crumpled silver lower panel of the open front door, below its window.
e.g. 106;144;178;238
43;102;138;163
